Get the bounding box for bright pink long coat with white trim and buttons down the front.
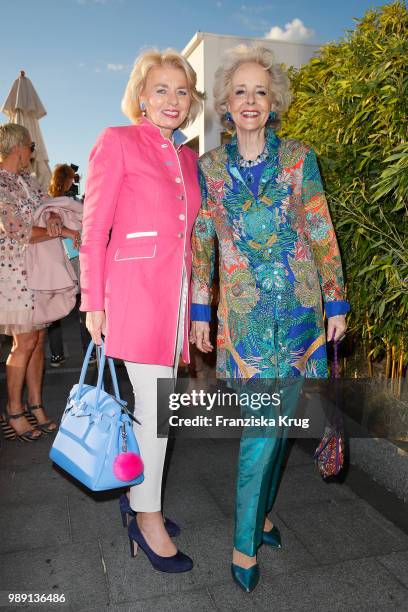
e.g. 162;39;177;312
80;119;200;365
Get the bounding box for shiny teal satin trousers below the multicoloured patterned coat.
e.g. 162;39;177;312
234;379;303;557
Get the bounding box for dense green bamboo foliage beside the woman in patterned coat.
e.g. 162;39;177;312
282;2;408;364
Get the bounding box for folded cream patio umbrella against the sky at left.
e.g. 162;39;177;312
1;70;51;191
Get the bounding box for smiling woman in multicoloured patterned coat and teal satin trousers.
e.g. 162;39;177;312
191;45;349;591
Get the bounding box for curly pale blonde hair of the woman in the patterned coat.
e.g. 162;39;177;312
213;45;292;132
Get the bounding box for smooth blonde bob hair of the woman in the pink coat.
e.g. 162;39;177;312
122;49;204;128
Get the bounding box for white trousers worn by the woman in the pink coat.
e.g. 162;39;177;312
125;269;188;512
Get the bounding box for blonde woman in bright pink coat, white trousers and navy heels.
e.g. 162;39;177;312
80;49;203;572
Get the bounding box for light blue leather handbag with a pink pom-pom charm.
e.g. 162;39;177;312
49;341;144;491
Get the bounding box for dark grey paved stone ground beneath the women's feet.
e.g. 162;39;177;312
0;318;408;612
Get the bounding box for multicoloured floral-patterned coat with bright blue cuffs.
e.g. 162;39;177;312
192;130;349;378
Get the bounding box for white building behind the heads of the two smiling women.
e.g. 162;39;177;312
182;32;319;155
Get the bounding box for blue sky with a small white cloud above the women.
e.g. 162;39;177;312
0;0;386;189
